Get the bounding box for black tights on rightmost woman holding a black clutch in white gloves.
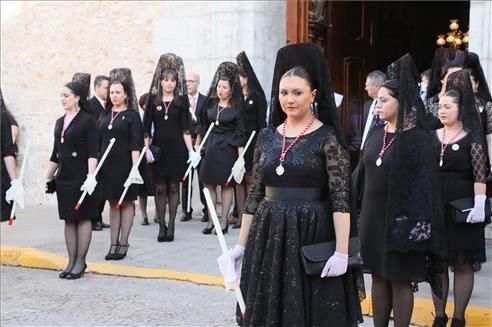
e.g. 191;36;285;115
432;263;474;320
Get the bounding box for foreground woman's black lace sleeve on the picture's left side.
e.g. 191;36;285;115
244;131;265;215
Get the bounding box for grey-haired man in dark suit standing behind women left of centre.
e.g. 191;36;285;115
181;72;208;222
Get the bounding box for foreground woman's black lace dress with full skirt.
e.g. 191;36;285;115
237;126;361;326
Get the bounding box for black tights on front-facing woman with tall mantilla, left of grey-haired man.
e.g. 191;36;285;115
155;181;179;235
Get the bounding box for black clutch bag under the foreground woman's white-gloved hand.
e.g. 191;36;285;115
301;237;362;276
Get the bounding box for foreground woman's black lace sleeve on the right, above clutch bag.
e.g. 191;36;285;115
324;132;350;212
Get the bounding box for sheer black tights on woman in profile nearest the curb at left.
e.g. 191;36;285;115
65;219;92;274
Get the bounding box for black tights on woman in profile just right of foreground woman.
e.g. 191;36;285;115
371;274;413;327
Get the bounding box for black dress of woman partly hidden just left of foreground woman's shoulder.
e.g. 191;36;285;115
241;93;267;173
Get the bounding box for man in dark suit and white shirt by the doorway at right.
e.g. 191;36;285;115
360;70;385;150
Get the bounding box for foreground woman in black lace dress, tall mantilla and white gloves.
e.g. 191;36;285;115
225;43;362;326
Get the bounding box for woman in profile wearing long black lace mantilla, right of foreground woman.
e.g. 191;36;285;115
357;54;443;326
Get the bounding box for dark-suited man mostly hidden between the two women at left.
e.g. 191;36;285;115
88;75;109;231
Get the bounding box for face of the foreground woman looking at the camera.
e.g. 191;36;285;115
278;76;316;118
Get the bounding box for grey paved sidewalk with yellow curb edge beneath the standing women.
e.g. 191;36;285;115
0;199;492;326
